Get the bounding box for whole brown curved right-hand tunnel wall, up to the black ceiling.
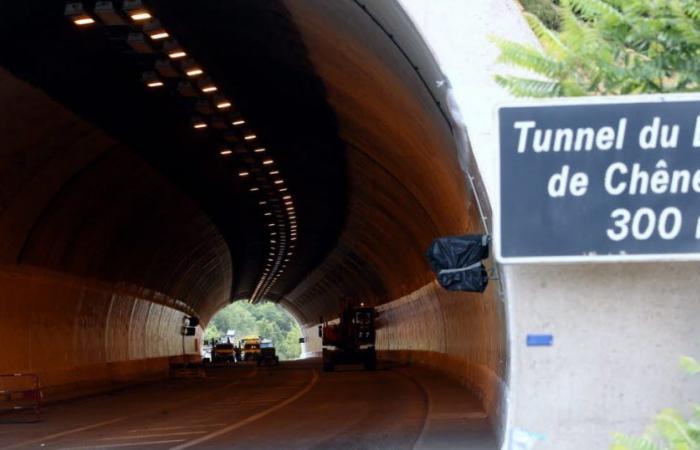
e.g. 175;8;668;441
283;1;507;436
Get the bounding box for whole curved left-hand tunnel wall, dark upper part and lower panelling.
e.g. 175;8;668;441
0;71;232;397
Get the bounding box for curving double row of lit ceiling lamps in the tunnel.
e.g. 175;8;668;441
65;0;298;302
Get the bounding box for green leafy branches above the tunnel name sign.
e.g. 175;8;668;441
494;0;700;97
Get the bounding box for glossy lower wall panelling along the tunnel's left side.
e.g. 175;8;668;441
0;268;201;400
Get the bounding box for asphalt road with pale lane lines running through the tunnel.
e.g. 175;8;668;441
0;359;496;450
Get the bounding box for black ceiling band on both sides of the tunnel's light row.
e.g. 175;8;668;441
0;0;347;300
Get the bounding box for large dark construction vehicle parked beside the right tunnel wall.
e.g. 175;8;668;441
319;303;377;372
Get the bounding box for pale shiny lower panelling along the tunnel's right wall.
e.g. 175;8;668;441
377;282;506;430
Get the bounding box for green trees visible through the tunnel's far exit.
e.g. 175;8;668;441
204;302;301;359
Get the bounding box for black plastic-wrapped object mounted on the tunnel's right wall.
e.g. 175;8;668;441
426;234;491;292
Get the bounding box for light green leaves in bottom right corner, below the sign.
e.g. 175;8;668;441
611;356;700;450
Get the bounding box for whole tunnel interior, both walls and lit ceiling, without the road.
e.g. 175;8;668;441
0;0;507;446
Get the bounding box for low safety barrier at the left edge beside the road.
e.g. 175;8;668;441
0;373;43;422
